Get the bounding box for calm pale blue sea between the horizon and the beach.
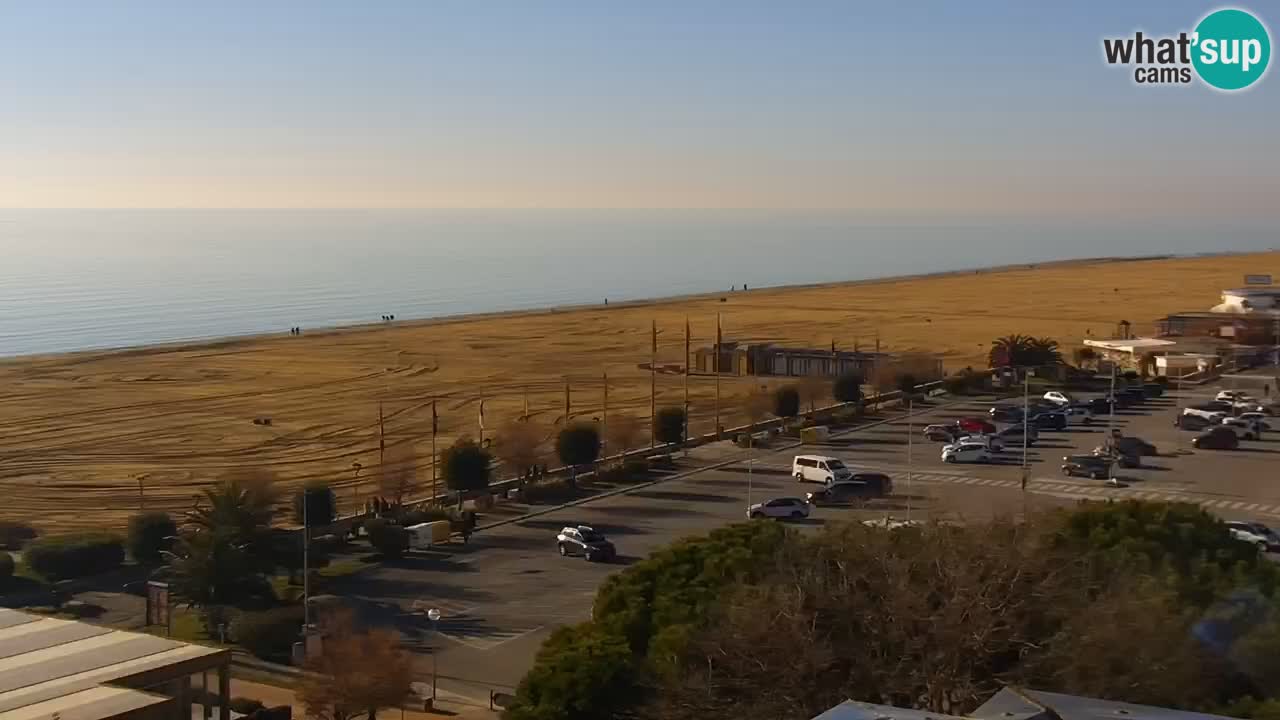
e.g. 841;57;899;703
0;210;1277;355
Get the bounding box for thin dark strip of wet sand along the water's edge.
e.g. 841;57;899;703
0;251;1198;366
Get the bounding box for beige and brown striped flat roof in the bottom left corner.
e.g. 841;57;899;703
0;609;229;720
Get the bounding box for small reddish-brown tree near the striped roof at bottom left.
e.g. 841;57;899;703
297;611;413;720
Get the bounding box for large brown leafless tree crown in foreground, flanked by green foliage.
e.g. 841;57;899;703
648;521;1203;720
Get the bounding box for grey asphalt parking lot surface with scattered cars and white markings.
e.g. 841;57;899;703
325;376;1280;698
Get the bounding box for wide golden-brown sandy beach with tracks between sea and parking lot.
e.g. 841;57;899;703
0;252;1280;530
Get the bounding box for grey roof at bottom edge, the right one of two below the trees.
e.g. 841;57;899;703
969;688;1226;720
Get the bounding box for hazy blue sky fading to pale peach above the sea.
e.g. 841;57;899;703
0;0;1280;219
